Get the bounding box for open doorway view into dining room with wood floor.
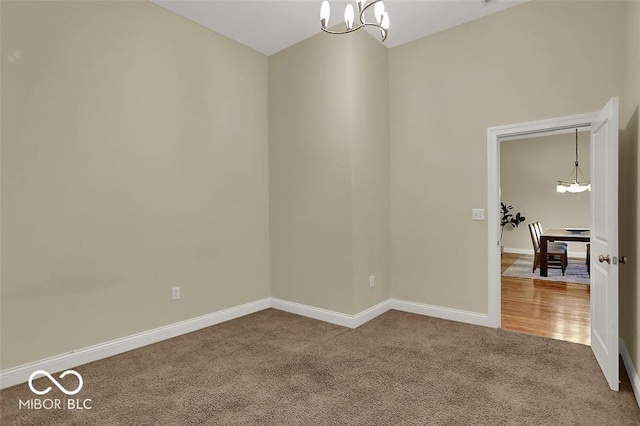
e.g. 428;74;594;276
500;131;591;345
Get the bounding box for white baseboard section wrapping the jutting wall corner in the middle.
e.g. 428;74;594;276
271;297;390;328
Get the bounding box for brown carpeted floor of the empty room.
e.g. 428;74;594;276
0;309;640;426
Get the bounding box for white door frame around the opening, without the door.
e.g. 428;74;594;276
487;112;598;328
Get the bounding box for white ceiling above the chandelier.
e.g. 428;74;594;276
151;0;527;55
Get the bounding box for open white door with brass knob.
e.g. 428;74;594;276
591;97;618;391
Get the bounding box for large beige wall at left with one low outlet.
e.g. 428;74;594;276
1;2;269;369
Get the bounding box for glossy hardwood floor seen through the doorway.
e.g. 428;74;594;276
502;253;591;345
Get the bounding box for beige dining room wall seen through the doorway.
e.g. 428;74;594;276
500;132;591;256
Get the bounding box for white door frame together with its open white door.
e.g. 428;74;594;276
487;97;619;391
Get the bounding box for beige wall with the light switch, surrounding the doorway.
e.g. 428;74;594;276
389;2;626;313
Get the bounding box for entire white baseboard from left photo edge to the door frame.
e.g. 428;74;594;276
0;297;490;389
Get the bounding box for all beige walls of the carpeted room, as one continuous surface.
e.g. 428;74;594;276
0;2;640;382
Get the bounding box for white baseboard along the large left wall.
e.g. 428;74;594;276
0;298;271;389
